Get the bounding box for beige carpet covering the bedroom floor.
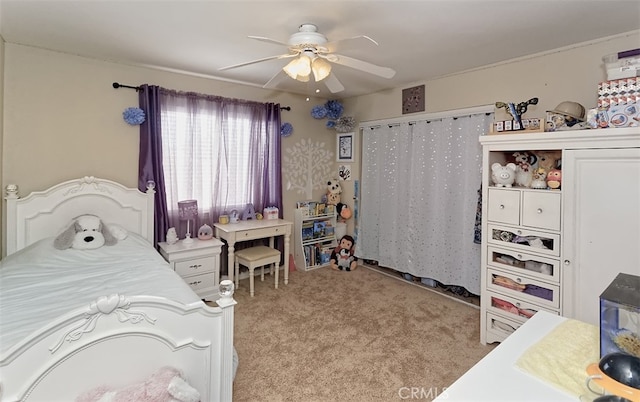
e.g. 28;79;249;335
225;267;493;402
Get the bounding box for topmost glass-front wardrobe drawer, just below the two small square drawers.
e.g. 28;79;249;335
488;223;560;257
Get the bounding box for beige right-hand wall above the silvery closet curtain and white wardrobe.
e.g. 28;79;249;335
336;31;640;236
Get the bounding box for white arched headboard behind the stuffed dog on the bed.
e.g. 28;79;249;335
5;176;155;255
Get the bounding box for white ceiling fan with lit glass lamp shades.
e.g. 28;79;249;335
218;23;396;93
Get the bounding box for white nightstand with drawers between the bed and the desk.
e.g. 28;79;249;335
158;237;224;300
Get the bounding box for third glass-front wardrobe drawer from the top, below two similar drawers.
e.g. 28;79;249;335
487;268;560;309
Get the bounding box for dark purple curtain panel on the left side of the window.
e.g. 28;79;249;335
138;84;169;245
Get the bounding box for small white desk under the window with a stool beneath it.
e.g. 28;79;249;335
214;219;293;285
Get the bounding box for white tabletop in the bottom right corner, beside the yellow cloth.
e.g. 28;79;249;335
435;310;579;402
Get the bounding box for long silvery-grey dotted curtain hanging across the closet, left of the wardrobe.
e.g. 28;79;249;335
357;113;492;294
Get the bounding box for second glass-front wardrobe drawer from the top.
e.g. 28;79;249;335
487;246;560;283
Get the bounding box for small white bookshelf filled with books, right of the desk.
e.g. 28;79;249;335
294;203;337;271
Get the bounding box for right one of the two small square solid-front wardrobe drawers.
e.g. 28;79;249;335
522;191;561;230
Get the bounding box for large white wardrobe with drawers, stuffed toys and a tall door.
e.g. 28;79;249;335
480;127;640;344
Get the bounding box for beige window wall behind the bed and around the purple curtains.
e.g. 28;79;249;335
0;43;335;256
